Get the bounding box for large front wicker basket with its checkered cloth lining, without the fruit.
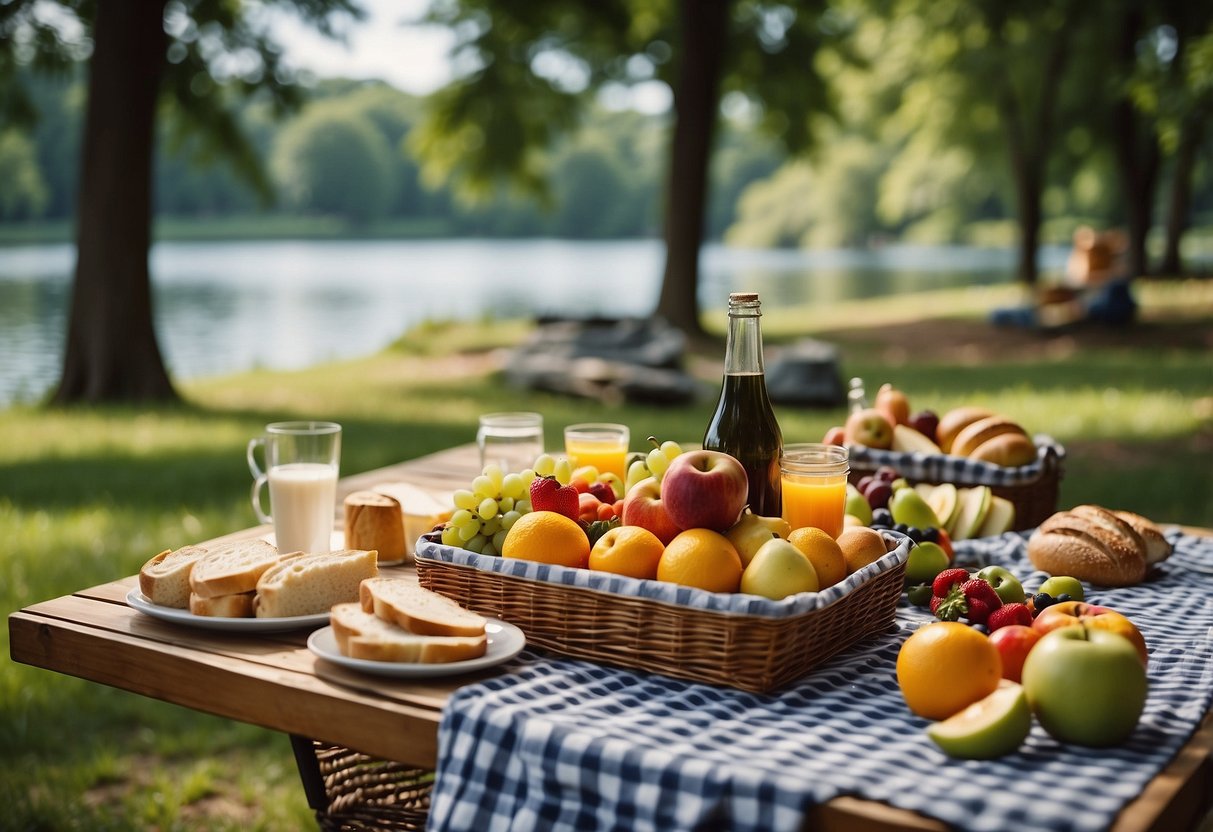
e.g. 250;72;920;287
416;536;910;693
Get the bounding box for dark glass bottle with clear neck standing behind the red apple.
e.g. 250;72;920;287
704;292;784;517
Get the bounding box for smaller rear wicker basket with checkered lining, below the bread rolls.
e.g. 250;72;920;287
850;434;1065;530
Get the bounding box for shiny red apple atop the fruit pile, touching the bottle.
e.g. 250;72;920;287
661;450;750;532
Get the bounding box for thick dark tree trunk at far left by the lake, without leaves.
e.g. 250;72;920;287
53;0;177;404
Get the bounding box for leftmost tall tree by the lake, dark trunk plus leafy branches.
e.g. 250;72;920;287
0;0;361;404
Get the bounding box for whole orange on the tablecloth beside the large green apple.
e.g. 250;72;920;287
898;621;1002;719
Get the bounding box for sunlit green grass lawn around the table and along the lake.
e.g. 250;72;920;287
0;281;1213;830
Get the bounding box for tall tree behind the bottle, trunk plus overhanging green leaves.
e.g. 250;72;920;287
414;0;838;335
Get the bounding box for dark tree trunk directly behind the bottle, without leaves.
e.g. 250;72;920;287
656;0;729;336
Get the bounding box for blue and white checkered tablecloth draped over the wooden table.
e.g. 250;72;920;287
429;534;1213;832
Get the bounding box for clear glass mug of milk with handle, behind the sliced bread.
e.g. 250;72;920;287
249;422;341;553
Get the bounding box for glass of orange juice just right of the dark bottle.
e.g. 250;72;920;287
779;443;850;537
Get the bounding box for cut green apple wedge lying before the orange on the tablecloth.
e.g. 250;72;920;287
927;679;1032;759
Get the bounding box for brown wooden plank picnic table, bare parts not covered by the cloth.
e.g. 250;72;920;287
8;445;1213;830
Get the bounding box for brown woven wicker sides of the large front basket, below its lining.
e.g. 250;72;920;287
416;540;909;693
